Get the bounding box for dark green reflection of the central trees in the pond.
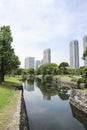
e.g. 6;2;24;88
37;80;70;100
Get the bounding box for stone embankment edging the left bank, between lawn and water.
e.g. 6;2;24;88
12;86;30;130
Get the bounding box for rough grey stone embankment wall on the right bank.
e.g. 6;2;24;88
70;89;87;114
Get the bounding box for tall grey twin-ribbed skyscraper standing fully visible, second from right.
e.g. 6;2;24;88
70;40;79;68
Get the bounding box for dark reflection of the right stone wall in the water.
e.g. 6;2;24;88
70;104;87;130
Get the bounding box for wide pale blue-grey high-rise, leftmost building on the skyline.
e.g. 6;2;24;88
25;57;35;69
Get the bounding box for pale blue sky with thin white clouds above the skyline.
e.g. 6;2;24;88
0;0;87;67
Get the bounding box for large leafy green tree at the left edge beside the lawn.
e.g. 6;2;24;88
0;26;20;82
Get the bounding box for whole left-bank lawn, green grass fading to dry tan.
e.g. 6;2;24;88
0;77;21;130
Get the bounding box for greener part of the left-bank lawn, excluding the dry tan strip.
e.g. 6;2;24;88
0;77;22;110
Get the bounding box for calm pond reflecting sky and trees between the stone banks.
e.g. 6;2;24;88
23;81;87;130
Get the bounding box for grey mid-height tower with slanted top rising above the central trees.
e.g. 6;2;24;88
43;48;51;63
